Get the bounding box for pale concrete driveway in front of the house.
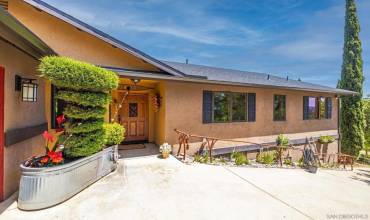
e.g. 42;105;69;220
0;156;370;220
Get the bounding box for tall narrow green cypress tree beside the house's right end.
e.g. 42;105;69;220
338;0;365;156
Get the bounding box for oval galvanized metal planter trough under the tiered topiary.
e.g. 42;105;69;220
18;145;119;210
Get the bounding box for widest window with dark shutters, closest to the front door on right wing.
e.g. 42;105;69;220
203;91;256;123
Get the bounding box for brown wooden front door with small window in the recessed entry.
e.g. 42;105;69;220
119;94;148;142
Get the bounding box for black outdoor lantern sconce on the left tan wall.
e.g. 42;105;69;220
15;75;38;102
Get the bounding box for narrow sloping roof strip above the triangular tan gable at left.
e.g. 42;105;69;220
23;0;185;77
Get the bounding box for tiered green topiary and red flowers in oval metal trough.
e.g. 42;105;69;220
18;56;124;210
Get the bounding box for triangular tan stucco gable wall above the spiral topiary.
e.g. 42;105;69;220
9;0;157;71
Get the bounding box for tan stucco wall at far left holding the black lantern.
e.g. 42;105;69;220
0;41;46;198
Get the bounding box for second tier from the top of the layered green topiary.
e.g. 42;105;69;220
55;90;112;107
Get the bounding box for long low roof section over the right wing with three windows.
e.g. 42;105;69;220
162;61;357;95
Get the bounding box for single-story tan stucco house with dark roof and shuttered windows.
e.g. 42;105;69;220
0;0;356;201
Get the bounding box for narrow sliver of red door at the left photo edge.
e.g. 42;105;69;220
0;66;5;201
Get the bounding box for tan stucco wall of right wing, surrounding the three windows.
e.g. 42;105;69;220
164;81;337;144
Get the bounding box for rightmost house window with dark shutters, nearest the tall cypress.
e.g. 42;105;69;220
303;96;332;120
